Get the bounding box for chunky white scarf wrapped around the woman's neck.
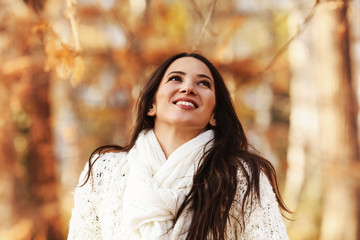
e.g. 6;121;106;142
122;130;214;240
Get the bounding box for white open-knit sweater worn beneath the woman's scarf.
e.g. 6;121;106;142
68;152;288;240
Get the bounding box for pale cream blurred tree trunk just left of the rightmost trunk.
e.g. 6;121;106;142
284;11;323;240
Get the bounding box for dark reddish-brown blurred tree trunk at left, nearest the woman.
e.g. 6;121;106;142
23;67;63;240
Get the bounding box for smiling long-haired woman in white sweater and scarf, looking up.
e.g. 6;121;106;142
68;53;288;240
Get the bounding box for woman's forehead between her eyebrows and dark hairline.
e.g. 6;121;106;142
164;57;213;78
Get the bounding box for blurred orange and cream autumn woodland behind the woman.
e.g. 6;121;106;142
0;0;360;240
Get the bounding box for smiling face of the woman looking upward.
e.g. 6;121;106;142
148;57;215;132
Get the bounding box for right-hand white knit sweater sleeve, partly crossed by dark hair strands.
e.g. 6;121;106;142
227;173;289;240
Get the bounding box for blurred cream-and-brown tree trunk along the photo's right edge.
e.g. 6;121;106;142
313;1;359;240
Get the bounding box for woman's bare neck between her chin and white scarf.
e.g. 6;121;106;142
154;124;203;158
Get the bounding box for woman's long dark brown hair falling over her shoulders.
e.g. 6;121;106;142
84;53;290;240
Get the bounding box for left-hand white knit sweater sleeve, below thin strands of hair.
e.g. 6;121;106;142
68;155;104;240
